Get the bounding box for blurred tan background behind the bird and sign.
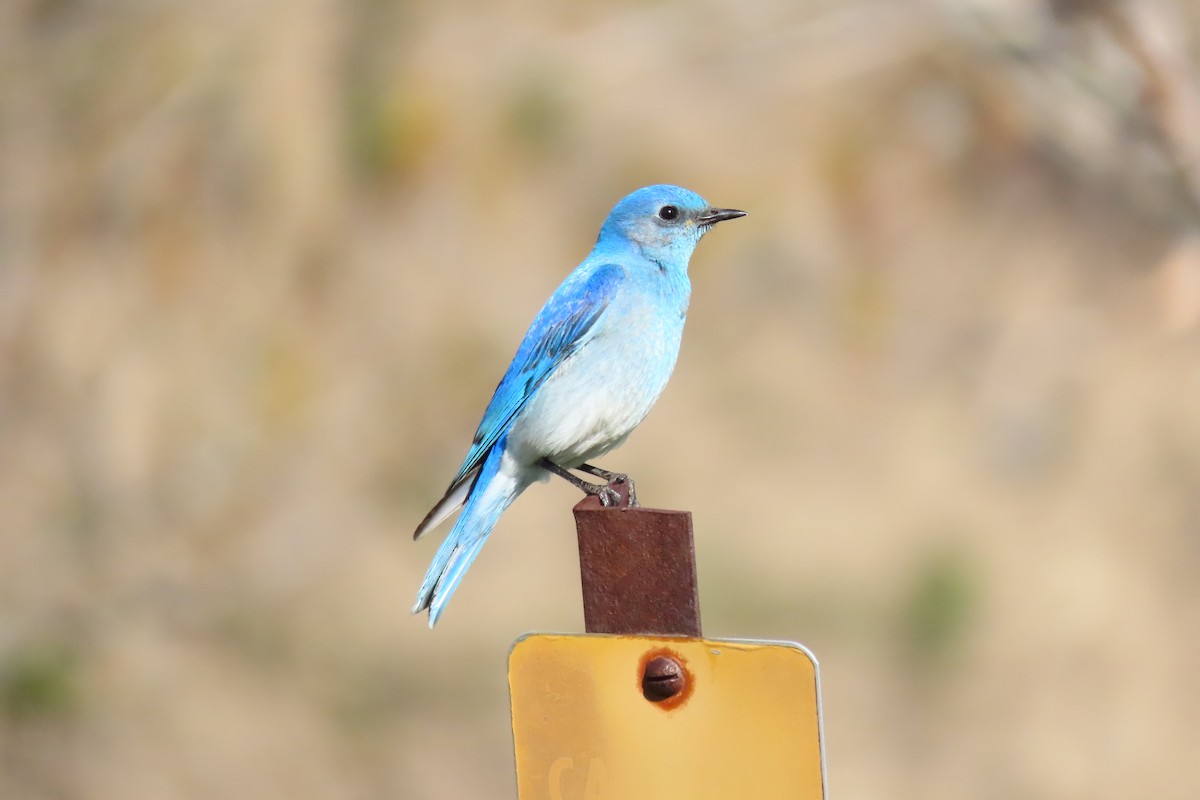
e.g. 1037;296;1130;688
0;0;1200;800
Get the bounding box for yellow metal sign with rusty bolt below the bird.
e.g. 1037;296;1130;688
509;634;824;800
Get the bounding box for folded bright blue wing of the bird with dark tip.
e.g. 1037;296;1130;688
413;264;625;539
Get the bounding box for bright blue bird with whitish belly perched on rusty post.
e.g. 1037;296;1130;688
413;185;745;627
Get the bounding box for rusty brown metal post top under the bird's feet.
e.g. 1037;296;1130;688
575;483;701;638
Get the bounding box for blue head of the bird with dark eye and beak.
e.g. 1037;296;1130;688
599;184;745;267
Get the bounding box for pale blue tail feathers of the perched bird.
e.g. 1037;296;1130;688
413;438;528;627
